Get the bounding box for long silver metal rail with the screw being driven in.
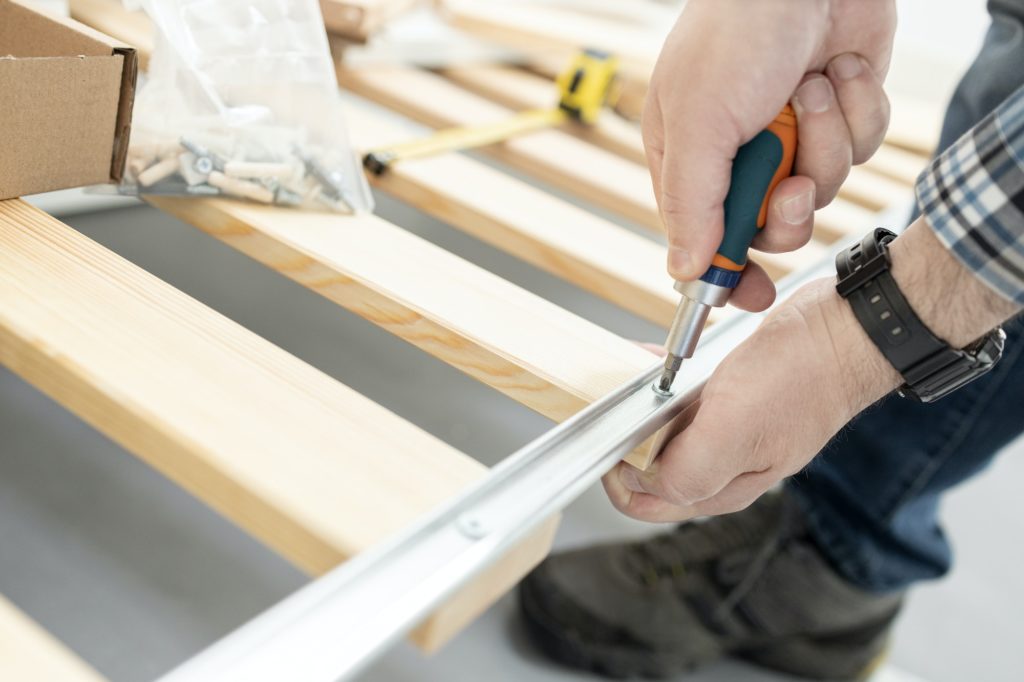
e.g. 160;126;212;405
155;253;831;682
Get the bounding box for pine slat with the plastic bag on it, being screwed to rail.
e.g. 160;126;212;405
151;198;652;420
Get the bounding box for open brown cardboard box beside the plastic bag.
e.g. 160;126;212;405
0;0;138;199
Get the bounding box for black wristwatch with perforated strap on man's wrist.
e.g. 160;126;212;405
836;227;1007;402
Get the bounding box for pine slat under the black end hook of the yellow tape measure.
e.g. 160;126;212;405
345;108;679;326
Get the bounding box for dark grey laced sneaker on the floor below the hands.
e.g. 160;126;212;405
519;493;902;680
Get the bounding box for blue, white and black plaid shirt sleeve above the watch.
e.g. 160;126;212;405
916;87;1024;305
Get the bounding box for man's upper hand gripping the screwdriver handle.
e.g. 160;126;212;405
643;0;896;310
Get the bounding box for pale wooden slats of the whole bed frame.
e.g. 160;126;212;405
0;0;938;680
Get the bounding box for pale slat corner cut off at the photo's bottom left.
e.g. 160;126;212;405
0;597;105;682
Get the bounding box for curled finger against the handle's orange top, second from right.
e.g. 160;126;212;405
793;74;853;208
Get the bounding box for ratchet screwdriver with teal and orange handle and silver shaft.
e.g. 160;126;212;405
655;104;797;394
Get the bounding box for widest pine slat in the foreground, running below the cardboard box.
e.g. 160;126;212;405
0;200;554;644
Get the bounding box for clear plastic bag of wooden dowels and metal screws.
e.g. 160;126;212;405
119;0;373;211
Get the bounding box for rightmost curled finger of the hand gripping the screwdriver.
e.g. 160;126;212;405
825;53;889;164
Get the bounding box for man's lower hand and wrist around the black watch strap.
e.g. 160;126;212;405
604;220;1017;521
